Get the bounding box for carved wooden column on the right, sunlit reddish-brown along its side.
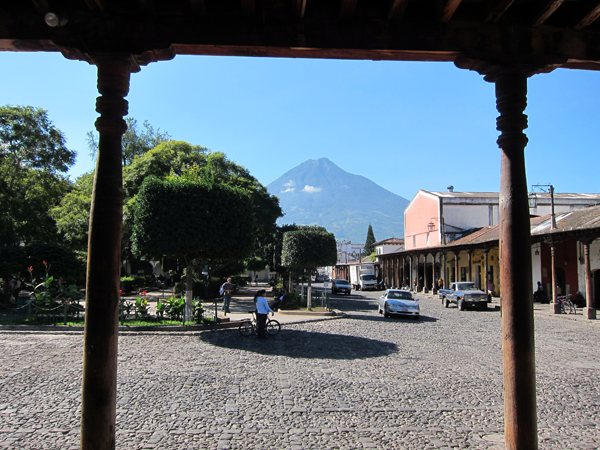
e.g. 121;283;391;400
486;68;538;450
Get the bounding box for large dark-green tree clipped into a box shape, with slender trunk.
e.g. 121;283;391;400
132;178;253;317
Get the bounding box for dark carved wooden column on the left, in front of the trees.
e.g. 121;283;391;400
81;59;130;450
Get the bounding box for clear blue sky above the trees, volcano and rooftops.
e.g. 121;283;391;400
0;53;600;200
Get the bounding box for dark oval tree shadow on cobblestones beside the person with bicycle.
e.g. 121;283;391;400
198;327;398;359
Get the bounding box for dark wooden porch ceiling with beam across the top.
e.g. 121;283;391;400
0;0;600;74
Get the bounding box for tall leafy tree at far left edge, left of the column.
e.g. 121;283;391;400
0;105;75;244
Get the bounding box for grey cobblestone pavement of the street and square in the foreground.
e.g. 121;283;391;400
0;293;600;450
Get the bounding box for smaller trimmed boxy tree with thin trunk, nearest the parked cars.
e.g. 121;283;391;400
281;226;337;309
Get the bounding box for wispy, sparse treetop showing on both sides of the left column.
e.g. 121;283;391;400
87;117;171;166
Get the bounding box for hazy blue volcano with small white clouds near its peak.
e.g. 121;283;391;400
267;158;409;243
